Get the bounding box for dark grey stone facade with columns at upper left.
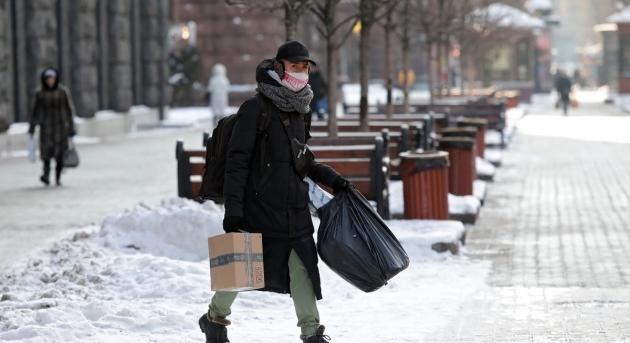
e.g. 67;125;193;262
0;0;170;122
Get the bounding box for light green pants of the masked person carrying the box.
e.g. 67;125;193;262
208;250;319;337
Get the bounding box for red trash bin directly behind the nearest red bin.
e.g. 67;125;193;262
438;137;477;195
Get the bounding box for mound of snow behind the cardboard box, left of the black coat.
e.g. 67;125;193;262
100;198;224;261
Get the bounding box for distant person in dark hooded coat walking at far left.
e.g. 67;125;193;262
28;68;75;186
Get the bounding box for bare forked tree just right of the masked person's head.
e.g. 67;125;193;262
311;0;357;137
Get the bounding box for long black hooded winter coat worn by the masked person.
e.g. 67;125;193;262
223;63;339;299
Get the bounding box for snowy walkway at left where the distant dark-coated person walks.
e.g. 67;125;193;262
0;129;201;270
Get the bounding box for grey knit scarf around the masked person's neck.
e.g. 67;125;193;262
256;77;313;114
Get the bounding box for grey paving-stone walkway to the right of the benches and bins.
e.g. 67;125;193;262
426;103;630;342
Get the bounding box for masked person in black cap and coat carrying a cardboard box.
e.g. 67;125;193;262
199;41;350;343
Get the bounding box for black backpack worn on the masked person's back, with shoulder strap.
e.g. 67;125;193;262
199;94;270;204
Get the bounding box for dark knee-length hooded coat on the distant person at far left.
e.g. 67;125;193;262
28;73;75;160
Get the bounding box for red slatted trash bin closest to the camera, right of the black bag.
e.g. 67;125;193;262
400;151;449;219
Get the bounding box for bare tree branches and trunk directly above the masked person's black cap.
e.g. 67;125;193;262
225;0;313;41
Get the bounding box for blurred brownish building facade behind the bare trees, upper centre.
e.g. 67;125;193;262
171;0;425;101
